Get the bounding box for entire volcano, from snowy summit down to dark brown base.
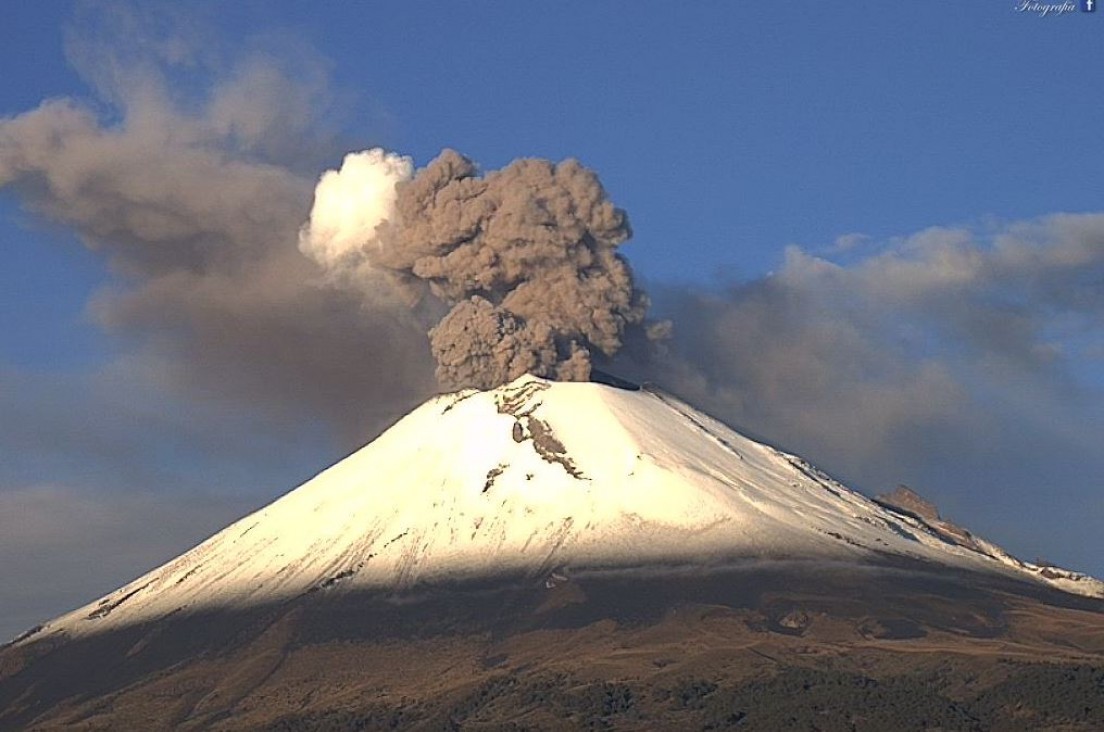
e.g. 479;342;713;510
0;376;1104;730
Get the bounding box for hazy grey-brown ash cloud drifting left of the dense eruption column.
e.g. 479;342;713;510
0;6;435;447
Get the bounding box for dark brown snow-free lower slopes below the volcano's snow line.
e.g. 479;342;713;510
0;563;1104;730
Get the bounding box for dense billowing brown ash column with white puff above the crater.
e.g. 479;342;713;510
299;149;661;390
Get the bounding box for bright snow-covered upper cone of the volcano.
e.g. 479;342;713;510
28;376;1104;635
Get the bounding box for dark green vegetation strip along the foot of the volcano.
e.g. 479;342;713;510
268;665;1104;732
